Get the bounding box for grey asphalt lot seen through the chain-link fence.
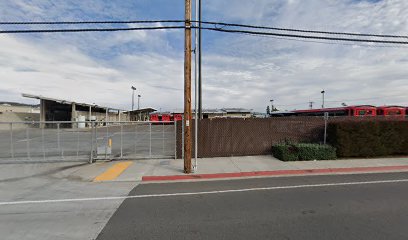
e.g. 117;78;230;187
0;124;175;163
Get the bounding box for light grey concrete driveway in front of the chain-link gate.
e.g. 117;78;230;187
0;163;138;240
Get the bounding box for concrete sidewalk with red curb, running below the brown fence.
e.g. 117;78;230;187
81;156;408;181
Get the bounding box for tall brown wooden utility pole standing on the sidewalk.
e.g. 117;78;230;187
184;0;192;173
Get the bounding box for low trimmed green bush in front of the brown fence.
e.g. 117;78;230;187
272;143;336;161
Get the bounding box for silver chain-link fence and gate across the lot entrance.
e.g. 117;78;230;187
0;122;176;163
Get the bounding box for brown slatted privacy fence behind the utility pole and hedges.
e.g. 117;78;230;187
176;117;406;158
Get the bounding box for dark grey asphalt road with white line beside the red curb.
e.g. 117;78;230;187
97;173;408;240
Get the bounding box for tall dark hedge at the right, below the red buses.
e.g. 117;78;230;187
328;121;408;157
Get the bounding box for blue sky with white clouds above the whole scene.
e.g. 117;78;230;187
0;0;408;112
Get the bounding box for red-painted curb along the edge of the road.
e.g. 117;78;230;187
142;165;408;182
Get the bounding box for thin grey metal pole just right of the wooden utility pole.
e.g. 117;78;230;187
193;0;199;171
